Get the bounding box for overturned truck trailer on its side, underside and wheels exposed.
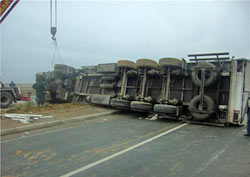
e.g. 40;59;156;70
53;53;250;125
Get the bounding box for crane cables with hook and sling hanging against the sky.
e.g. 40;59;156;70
50;0;63;68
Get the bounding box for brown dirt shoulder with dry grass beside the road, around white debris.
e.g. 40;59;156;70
1;103;113;130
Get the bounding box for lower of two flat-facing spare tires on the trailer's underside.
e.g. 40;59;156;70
189;95;214;121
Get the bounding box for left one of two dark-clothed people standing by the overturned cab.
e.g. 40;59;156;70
33;79;46;106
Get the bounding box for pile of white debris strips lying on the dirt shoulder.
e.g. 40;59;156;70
2;114;53;123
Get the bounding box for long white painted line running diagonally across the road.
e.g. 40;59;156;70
60;123;188;177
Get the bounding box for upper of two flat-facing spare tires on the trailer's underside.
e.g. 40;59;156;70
191;62;218;87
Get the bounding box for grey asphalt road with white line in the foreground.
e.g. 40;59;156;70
1;113;250;177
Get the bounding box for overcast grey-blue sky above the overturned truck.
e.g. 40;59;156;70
1;0;250;82
